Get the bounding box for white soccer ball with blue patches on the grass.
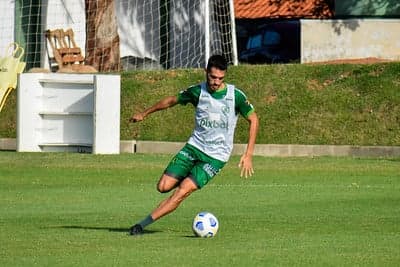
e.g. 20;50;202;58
192;211;219;237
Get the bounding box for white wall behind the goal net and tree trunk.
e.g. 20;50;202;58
0;0;204;68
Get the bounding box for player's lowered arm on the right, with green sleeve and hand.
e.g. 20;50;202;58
235;90;259;178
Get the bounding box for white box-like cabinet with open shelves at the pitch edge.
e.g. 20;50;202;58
17;73;120;154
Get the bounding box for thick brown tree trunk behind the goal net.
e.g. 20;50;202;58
85;0;120;72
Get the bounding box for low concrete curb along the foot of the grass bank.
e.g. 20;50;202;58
0;138;400;157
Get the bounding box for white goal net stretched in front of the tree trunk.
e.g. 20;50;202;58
0;0;237;72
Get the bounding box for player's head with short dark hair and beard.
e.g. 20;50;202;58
206;55;228;91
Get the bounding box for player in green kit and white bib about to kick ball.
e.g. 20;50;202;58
129;55;258;235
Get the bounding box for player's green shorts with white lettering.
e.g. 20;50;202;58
164;144;225;189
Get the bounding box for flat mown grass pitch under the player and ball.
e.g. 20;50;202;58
0;151;400;266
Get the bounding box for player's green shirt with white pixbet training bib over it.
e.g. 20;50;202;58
178;83;254;162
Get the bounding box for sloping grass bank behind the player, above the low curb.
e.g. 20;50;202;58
0;62;400;146
